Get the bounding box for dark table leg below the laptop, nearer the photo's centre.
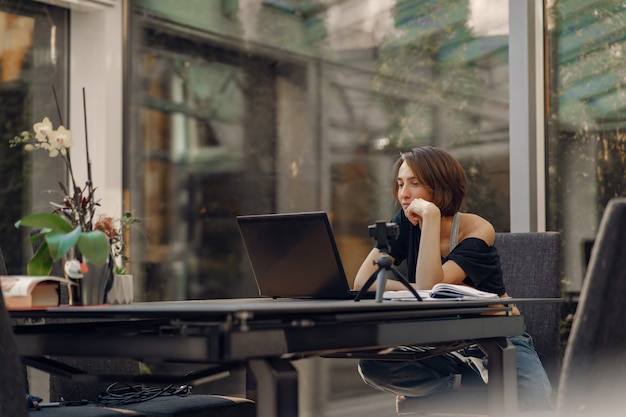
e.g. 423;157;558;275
246;358;298;417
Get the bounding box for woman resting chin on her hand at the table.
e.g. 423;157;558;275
354;146;551;410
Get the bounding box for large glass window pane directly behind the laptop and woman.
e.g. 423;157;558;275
125;0;509;299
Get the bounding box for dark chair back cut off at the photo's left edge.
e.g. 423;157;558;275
0;245;28;417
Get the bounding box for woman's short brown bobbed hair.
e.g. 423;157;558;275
393;146;466;216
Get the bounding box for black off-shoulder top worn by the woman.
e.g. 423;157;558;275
382;209;506;295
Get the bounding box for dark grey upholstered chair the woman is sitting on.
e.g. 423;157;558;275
396;232;562;416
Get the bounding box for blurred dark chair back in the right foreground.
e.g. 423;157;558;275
557;197;626;416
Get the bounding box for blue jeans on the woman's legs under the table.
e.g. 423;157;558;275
359;333;552;411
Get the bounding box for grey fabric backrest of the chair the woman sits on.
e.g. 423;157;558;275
495;232;562;386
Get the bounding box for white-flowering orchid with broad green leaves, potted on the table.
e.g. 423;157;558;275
10;90;137;304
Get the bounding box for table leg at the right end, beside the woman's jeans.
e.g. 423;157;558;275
480;338;518;416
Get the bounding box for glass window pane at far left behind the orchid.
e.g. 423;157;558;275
0;0;68;274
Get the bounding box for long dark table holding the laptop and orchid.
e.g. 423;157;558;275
11;298;537;417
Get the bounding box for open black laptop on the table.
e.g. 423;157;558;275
237;212;374;299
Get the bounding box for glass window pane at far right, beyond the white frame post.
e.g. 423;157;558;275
546;0;626;292
